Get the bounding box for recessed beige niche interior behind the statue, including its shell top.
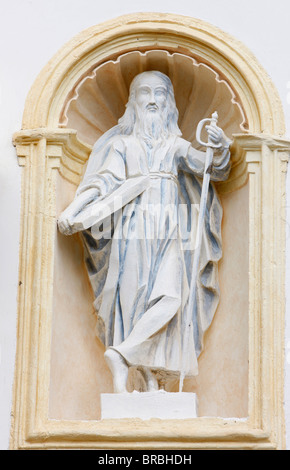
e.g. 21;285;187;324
50;49;248;419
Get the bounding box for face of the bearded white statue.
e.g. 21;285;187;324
135;74;167;114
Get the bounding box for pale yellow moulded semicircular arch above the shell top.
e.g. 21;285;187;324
22;13;285;136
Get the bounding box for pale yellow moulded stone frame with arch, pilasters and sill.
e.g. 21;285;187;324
11;13;290;449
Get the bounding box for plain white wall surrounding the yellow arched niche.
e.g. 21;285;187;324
0;0;290;449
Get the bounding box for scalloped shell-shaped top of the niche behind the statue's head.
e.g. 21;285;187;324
59;50;247;148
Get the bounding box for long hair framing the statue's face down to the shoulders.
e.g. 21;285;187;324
118;70;181;135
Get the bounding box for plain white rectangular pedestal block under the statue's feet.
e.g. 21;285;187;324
101;390;197;420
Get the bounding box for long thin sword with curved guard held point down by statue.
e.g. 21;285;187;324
179;112;222;392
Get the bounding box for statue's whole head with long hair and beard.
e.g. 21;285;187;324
119;71;181;138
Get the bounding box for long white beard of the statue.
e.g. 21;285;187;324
134;108;168;143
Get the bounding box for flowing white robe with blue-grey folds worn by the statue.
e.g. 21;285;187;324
65;126;230;376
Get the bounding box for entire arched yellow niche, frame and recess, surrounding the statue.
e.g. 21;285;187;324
12;14;289;448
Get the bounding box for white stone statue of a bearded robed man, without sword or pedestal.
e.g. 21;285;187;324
58;71;230;393
